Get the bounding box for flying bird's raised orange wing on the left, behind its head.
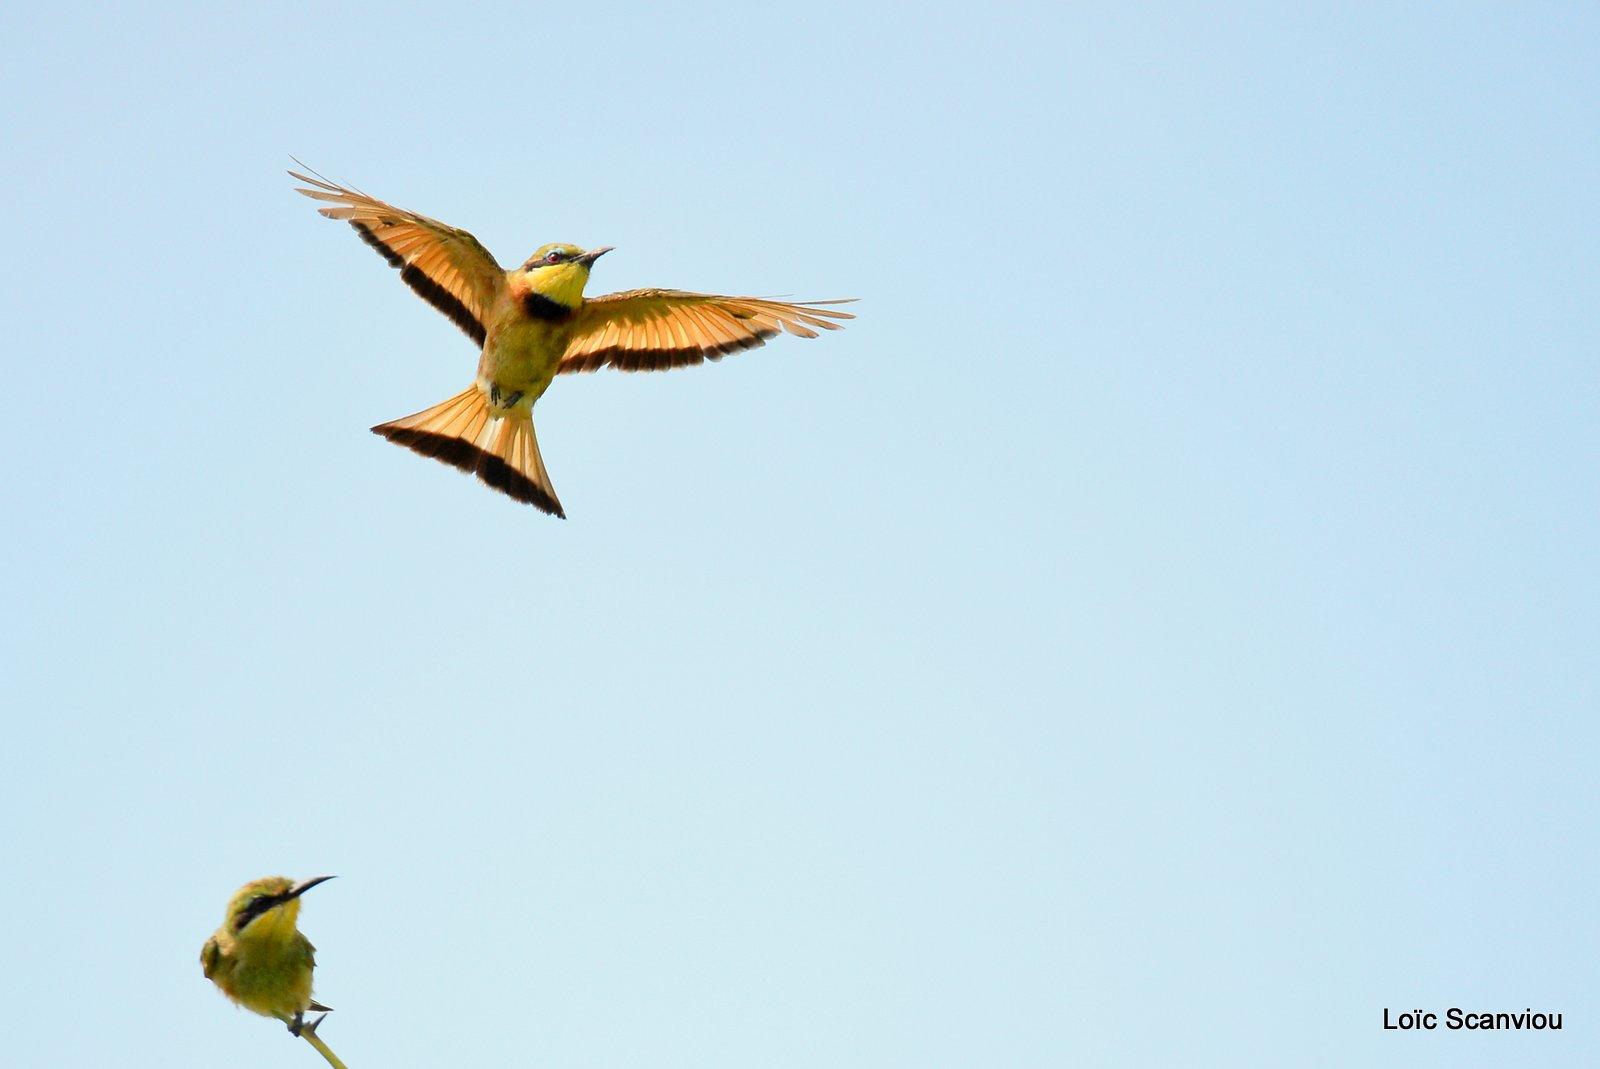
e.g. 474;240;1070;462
290;160;506;346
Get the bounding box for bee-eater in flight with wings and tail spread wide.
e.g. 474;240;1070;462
290;168;854;518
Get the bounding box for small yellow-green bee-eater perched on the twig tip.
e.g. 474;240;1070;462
200;875;333;1035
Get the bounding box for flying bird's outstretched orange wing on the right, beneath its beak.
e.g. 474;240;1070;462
558;290;856;373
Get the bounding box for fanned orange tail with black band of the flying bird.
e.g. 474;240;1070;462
373;386;566;520
